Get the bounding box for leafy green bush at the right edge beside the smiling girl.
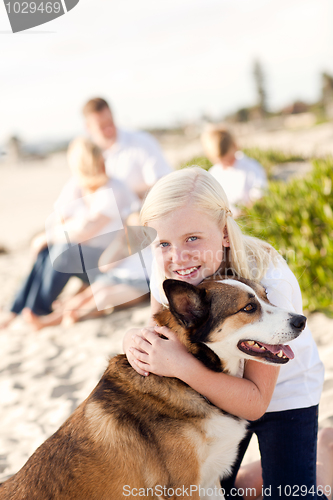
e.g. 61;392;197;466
240;157;333;312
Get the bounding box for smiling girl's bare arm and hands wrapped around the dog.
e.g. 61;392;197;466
129;327;279;420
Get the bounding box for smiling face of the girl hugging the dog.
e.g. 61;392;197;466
149;205;229;285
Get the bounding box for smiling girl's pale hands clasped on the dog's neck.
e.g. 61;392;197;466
129;326;192;377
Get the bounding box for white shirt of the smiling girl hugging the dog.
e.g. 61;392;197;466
150;259;324;412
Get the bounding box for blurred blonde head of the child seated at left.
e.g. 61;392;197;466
67;137;109;190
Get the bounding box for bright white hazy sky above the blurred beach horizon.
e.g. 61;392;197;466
0;0;333;143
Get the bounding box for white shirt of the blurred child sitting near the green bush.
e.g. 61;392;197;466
209;151;267;216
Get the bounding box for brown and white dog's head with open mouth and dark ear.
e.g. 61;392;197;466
163;279;306;372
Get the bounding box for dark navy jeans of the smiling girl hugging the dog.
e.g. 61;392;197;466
221;406;325;500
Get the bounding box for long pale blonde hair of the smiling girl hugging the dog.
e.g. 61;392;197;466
140;165;279;296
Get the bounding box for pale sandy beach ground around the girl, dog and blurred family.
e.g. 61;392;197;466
0;125;333;480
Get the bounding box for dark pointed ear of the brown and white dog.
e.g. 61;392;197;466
163;280;209;328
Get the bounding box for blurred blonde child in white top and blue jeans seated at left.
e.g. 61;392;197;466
0;138;140;327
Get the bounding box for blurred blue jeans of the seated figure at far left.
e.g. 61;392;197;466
10;245;104;316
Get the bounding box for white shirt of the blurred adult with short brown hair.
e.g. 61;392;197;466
104;129;172;192
